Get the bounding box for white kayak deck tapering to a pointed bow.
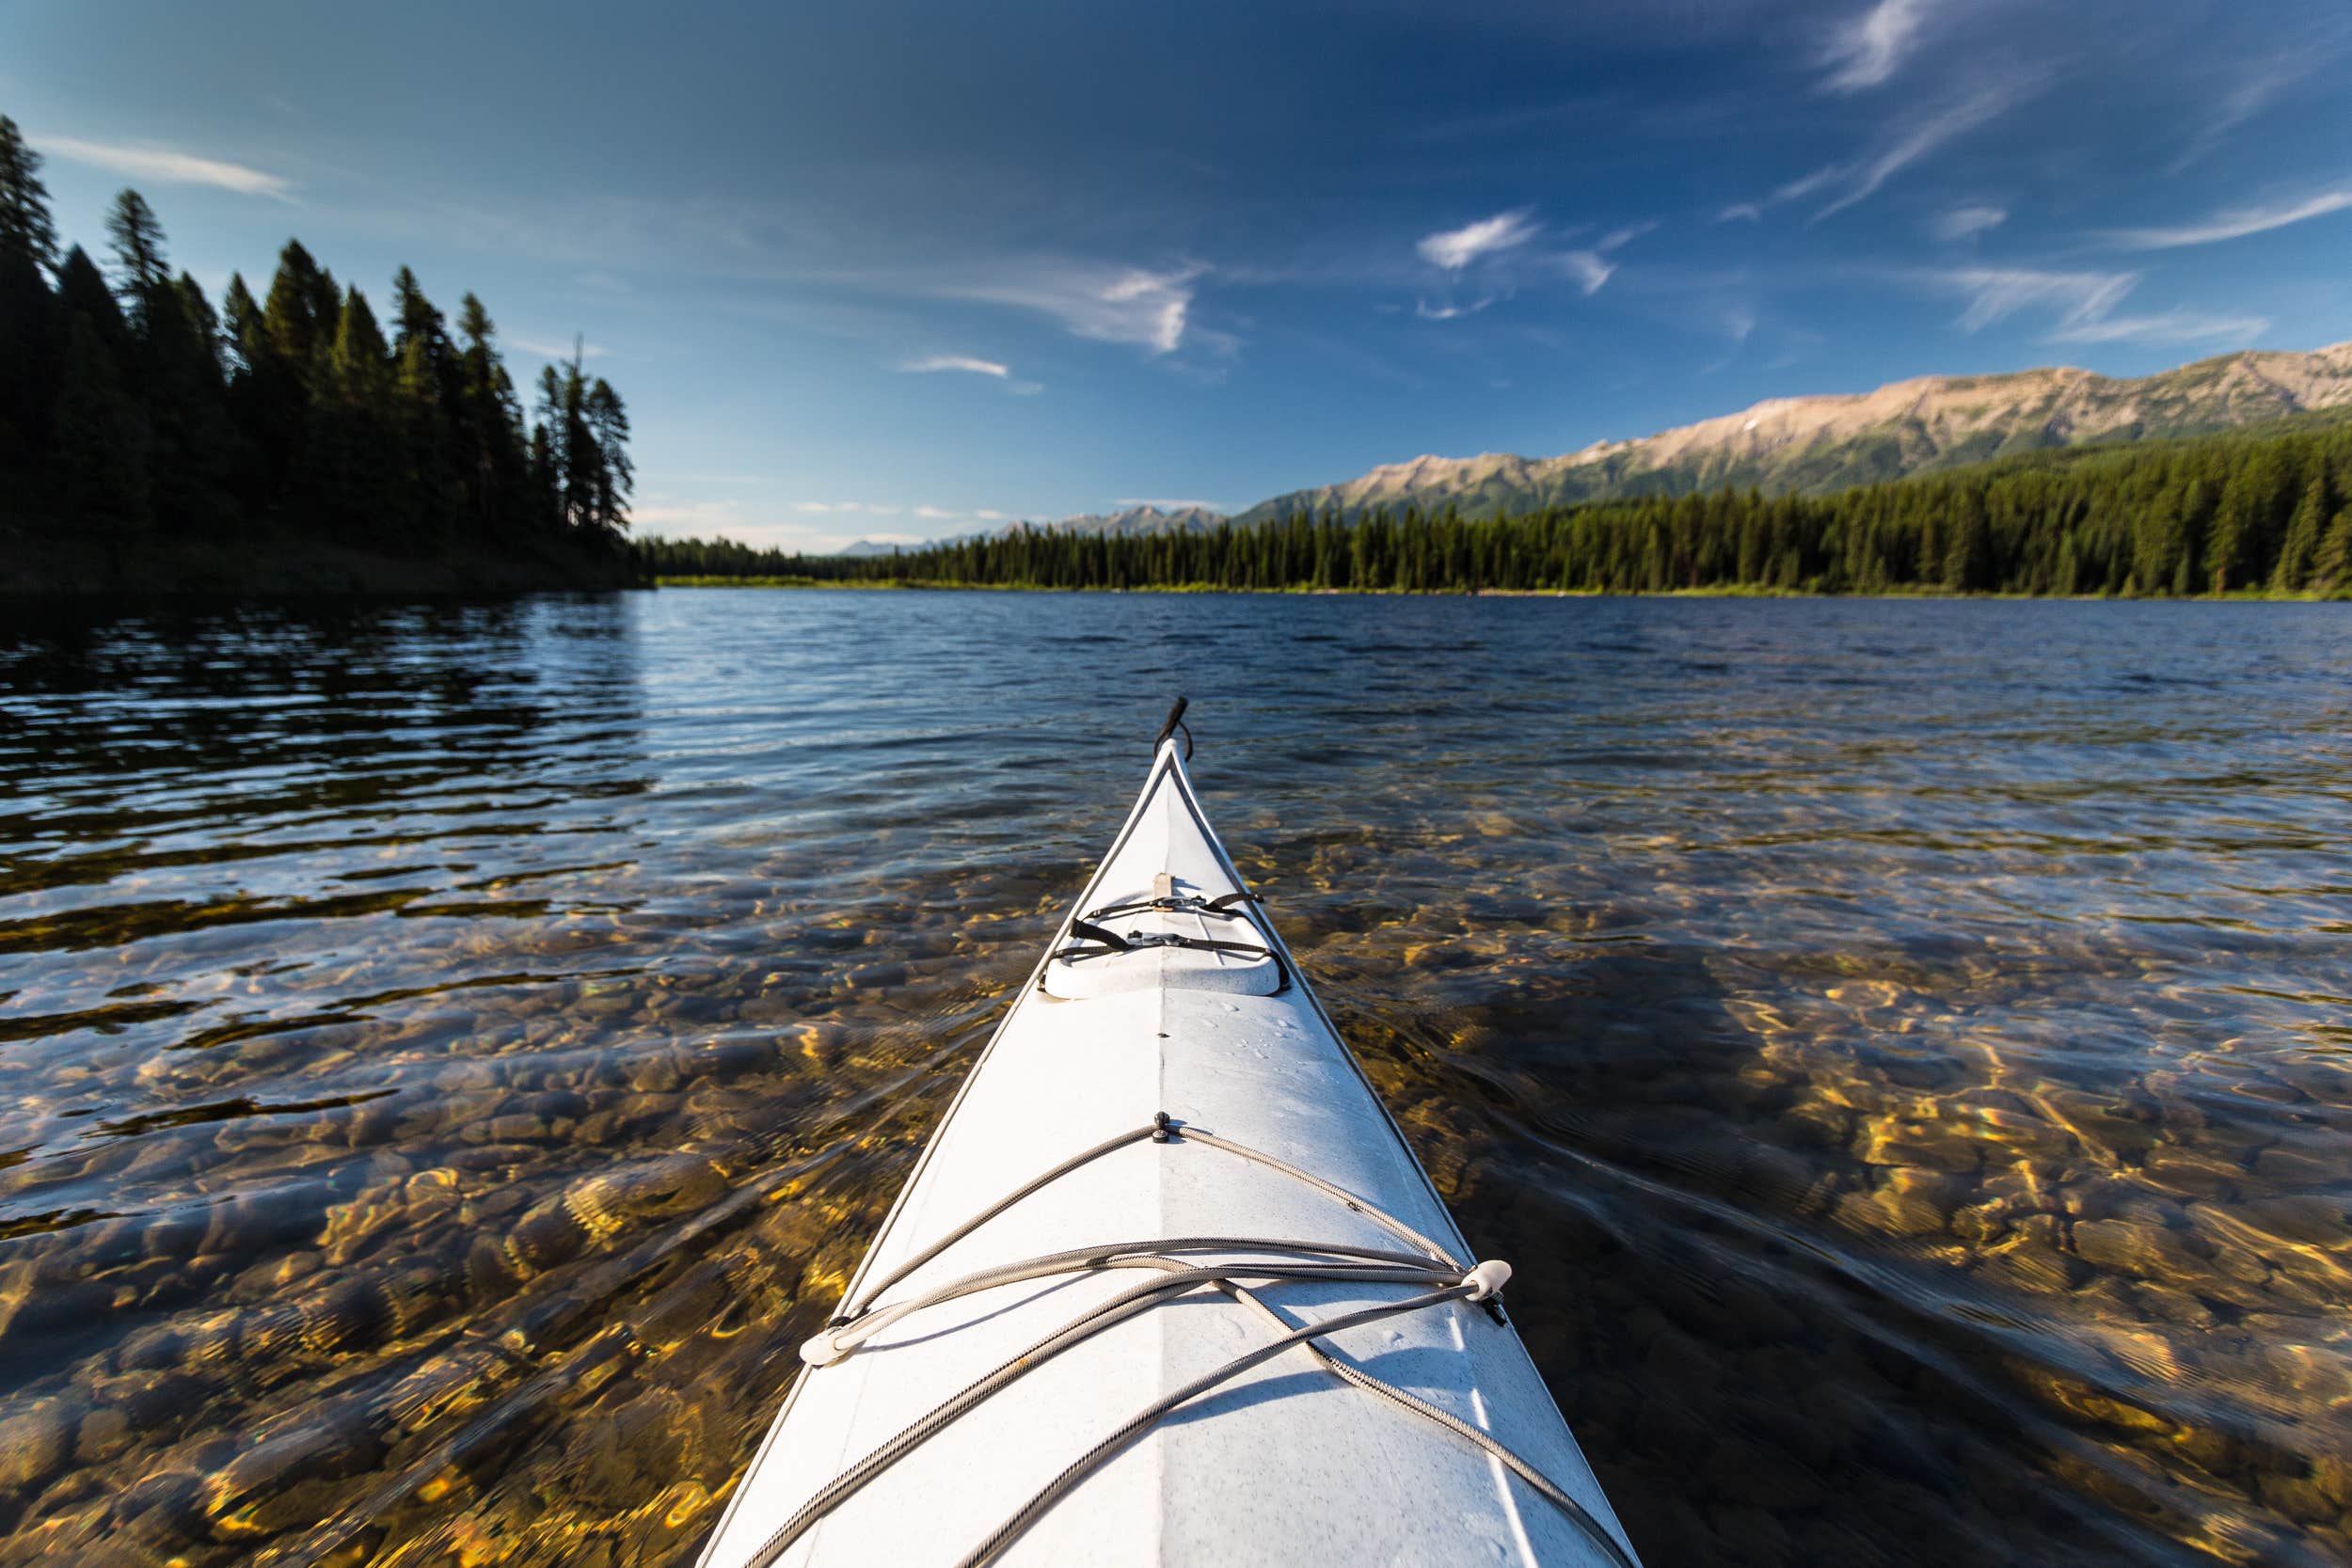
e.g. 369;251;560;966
701;743;1632;1568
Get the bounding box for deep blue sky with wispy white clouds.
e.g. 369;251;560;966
0;0;2352;547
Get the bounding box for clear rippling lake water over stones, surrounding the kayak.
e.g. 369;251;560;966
0;590;2352;1568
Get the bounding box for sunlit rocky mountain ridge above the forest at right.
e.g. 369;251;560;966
1235;343;2352;524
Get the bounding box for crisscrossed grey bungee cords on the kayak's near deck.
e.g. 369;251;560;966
746;1112;1637;1568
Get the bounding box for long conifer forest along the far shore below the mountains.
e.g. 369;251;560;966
638;423;2352;597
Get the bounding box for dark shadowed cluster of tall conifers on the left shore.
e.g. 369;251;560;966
0;115;633;571
